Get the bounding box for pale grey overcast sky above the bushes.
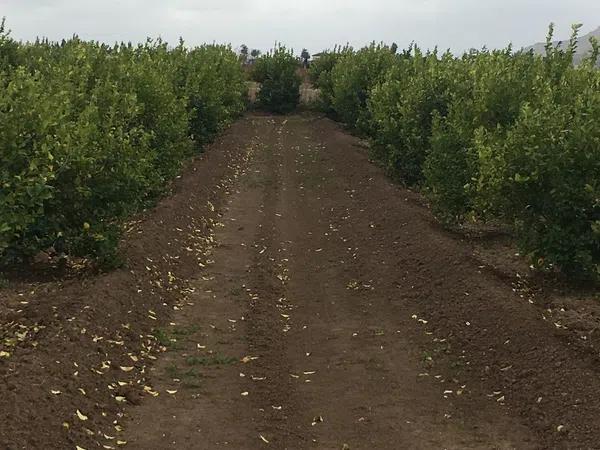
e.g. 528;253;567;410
0;0;600;52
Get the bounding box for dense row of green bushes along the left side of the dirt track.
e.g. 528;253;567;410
0;20;247;264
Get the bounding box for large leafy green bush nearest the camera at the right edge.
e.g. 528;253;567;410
477;65;600;277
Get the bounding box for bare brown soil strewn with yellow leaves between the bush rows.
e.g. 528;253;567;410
0;115;600;450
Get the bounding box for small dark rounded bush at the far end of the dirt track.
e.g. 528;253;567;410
252;46;301;114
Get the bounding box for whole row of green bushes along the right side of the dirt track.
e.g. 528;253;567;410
313;27;600;278
